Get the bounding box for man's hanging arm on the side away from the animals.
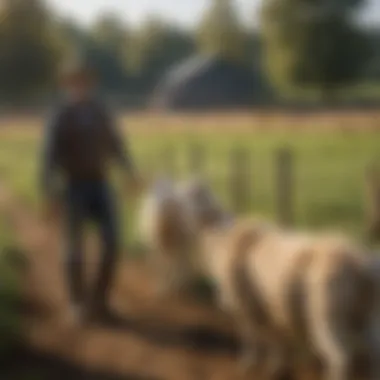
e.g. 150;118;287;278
40;107;60;198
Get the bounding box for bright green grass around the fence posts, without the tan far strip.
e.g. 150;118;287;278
0;124;380;246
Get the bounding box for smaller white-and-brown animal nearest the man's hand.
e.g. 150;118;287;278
140;178;196;295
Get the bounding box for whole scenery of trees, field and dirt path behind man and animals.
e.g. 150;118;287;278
0;0;380;380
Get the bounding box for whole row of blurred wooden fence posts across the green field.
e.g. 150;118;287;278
145;141;380;246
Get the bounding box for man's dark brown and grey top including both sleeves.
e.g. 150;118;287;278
41;100;134;193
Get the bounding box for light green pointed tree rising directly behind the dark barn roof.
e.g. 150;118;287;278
198;0;247;62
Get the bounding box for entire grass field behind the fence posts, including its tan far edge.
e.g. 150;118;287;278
0;111;380;245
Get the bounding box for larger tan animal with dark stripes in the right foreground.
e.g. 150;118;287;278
182;181;380;380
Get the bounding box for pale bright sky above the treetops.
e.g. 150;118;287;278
47;0;380;26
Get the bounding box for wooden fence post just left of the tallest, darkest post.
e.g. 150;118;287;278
229;147;252;214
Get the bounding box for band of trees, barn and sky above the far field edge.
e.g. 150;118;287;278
0;0;380;109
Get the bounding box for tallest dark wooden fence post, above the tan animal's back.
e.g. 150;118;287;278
275;148;294;226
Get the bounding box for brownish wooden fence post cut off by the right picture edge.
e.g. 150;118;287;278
366;164;380;240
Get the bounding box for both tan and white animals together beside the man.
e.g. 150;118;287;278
140;179;380;380
